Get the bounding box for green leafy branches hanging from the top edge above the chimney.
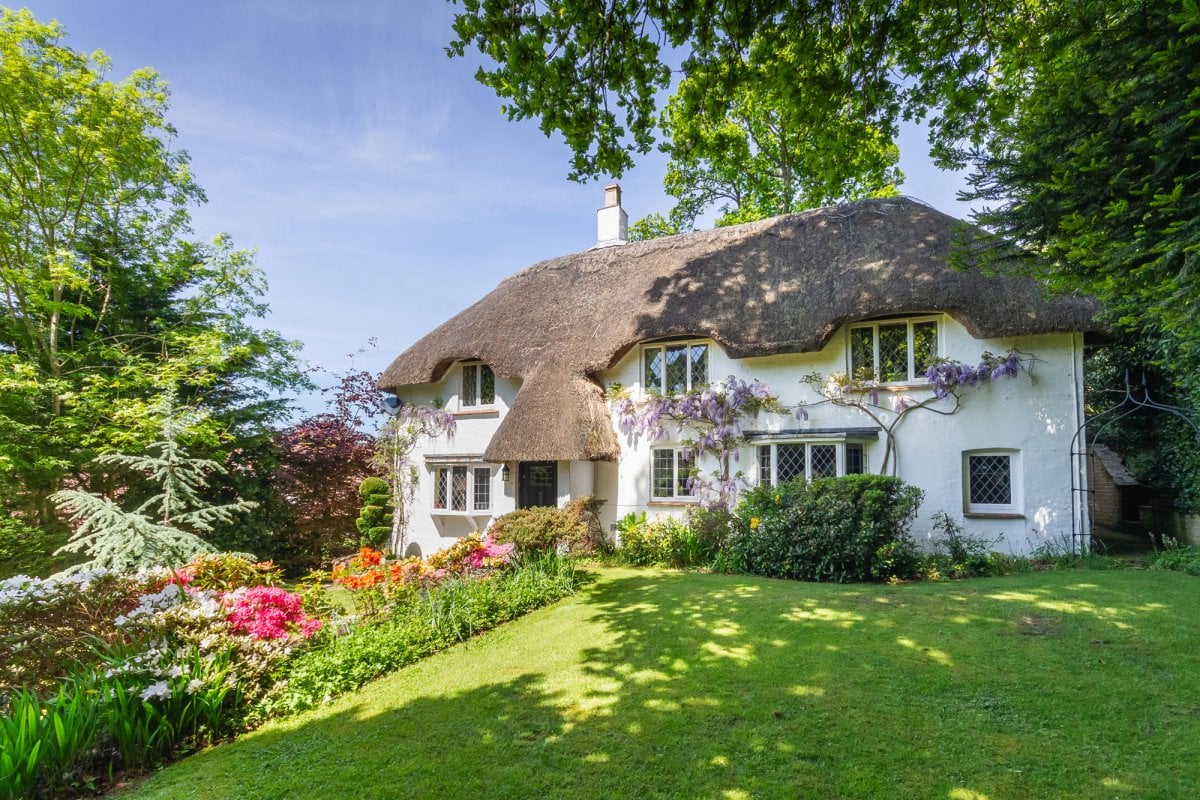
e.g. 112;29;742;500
448;0;1027;178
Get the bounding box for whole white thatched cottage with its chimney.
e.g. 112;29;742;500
379;186;1097;554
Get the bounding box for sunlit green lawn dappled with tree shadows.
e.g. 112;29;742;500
124;567;1200;800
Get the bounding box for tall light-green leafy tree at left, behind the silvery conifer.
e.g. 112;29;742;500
0;10;304;568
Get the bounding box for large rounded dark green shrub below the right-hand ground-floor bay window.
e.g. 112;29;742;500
728;475;923;583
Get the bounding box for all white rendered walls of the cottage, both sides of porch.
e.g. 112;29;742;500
392;315;1086;555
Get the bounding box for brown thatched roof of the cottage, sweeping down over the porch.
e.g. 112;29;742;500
379;198;1100;462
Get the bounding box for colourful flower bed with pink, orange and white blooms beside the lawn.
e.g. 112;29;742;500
0;535;574;800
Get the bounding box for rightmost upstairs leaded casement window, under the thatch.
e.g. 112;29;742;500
850;317;938;383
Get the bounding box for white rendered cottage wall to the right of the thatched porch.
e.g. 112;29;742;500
601;315;1082;553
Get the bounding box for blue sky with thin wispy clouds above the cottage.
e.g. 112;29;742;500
18;0;968;419
